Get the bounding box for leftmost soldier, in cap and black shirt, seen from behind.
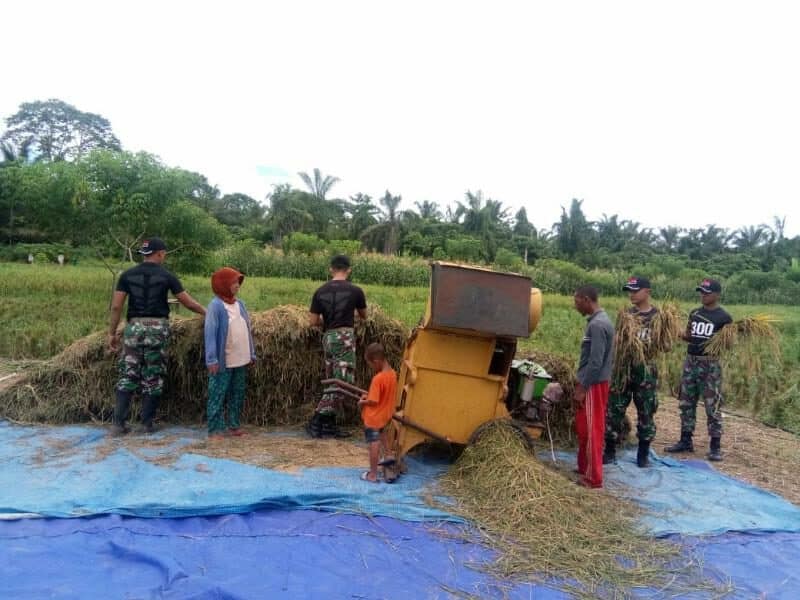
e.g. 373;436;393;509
108;238;206;435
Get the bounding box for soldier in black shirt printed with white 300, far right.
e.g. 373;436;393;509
666;279;733;461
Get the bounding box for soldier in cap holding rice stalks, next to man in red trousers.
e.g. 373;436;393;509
603;277;658;468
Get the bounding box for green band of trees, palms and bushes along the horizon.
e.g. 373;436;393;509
0;100;800;305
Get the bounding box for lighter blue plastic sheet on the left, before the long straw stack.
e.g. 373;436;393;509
0;423;458;521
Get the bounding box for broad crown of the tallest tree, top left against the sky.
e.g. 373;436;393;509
2;99;120;161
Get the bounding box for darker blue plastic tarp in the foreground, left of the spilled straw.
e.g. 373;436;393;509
0;510;568;600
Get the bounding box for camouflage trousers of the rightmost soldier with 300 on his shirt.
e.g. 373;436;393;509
678;354;722;437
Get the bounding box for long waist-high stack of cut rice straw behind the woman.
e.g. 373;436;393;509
0;306;407;425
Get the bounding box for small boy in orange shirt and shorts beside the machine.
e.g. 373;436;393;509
358;343;397;483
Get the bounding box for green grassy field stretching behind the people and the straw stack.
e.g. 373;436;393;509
0;263;800;431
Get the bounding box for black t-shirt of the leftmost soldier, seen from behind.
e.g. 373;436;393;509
117;262;183;320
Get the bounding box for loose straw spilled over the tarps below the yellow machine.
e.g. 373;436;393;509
437;424;728;598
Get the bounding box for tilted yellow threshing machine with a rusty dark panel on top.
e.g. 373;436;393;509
394;262;542;469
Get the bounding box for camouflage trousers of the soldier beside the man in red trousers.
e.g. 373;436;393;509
606;365;658;443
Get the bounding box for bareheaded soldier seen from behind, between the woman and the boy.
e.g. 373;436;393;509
306;255;367;437
